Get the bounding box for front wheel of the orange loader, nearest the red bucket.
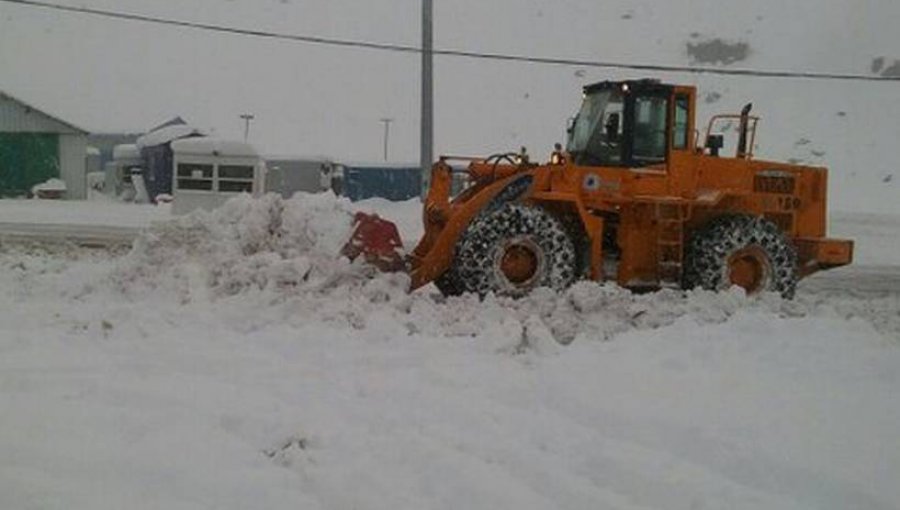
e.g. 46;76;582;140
448;203;576;297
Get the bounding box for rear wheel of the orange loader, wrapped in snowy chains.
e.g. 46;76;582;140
684;215;797;298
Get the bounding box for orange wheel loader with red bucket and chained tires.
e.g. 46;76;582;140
344;80;853;297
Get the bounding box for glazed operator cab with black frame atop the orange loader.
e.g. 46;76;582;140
566;80;693;168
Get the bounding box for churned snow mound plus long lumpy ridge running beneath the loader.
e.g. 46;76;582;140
98;193;900;351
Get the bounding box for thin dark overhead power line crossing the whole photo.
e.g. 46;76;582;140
0;0;900;82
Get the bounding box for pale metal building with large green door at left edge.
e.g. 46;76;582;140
0;92;88;199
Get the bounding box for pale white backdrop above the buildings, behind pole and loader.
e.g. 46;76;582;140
0;0;900;205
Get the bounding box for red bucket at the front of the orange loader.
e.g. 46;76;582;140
341;212;406;272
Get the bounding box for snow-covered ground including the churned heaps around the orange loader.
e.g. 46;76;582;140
0;195;900;509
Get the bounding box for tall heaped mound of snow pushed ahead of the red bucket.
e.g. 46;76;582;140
113;193;362;300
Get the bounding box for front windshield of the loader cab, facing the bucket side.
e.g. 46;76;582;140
566;90;624;165
